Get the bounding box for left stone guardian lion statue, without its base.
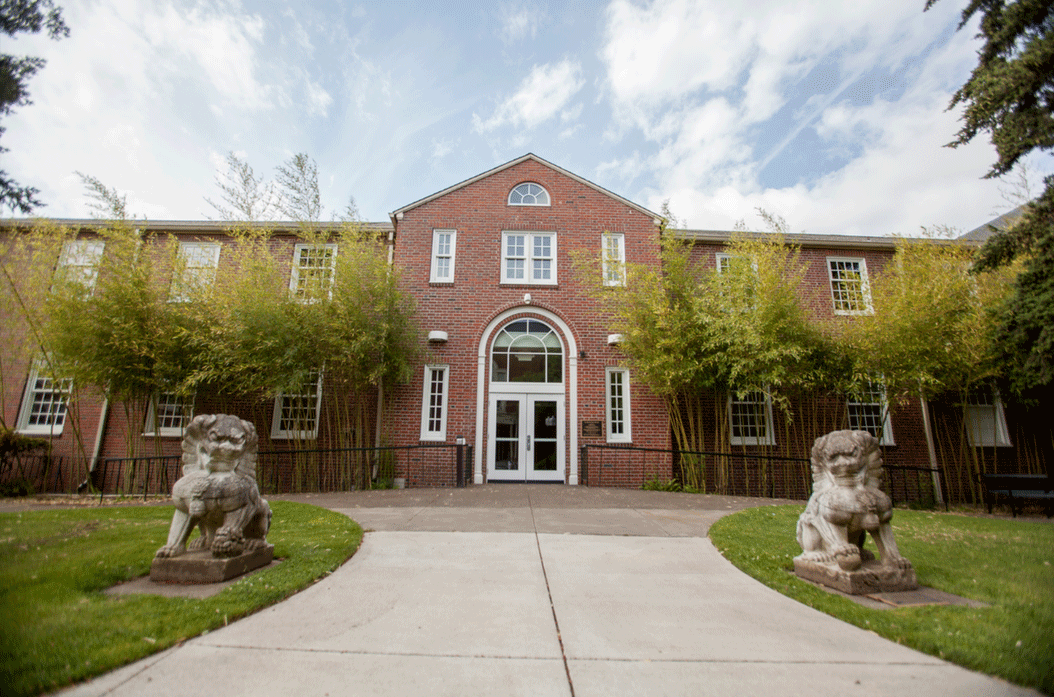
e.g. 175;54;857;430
155;414;271;558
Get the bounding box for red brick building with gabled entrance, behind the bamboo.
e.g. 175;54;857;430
3;154;1037;495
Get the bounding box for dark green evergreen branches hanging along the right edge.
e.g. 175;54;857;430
926;0;1054;393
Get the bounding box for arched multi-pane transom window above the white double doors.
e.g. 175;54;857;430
490;320;564;383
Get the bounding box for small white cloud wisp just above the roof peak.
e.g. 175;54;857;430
473;60;585;133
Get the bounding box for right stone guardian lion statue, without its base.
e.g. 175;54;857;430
795;430;912;572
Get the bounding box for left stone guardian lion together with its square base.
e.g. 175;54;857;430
150;414;274;583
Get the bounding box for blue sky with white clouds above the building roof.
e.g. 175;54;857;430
0;0;1054;235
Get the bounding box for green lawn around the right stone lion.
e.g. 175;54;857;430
710;505;1054;694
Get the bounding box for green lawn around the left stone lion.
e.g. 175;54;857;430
0;501;363;696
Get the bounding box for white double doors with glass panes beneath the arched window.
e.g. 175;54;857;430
487;393;564;482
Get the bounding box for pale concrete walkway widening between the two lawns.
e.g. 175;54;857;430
57;485;1037;697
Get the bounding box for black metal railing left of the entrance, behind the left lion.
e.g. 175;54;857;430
92;443;472;498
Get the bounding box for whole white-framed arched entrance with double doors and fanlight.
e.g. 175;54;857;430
475;308;578;484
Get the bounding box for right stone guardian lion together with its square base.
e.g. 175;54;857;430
794;430;918;595
